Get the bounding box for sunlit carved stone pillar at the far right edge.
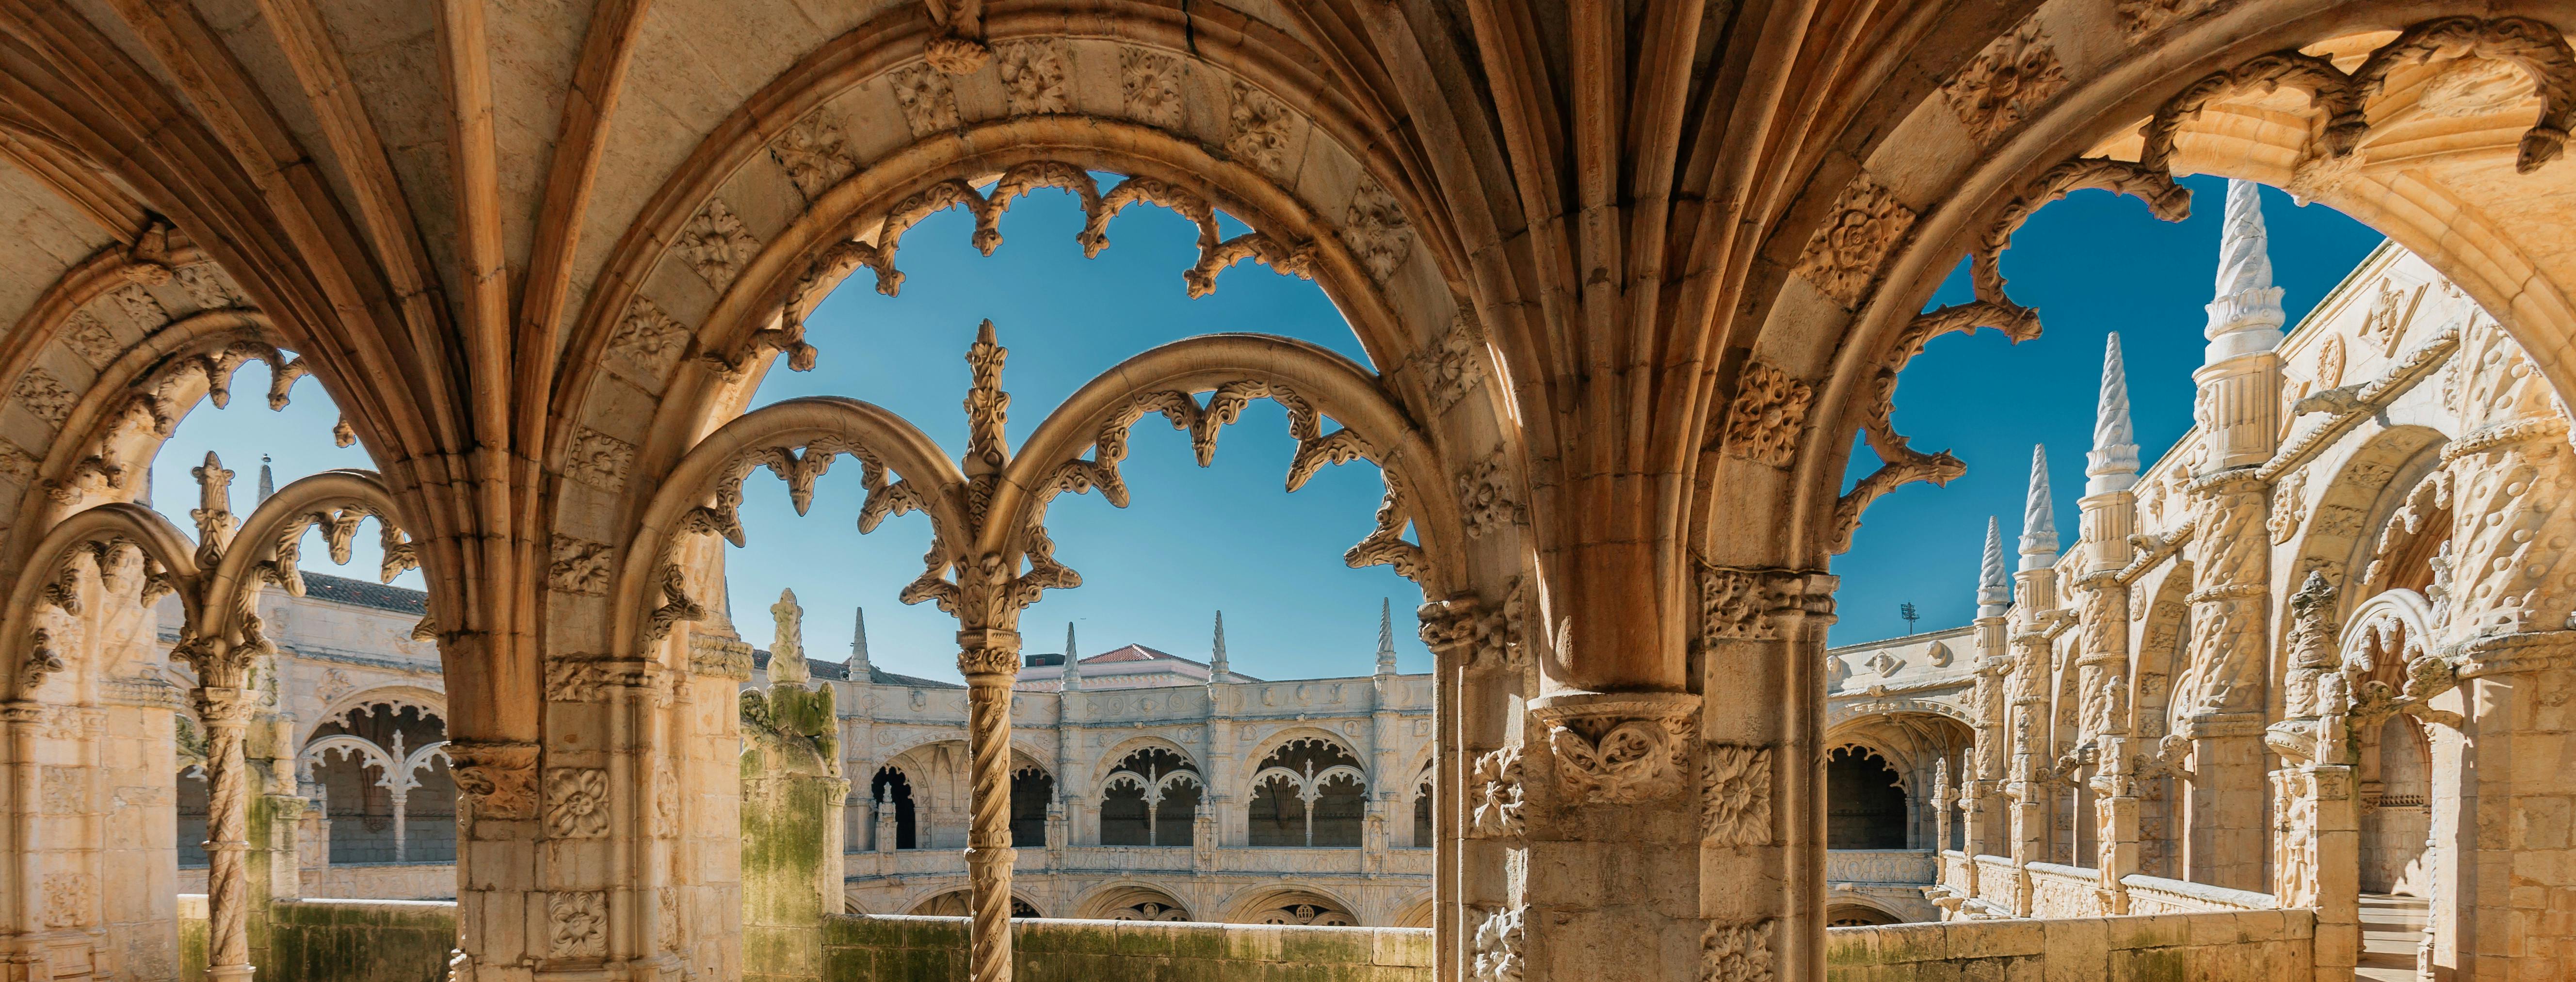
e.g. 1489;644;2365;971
2411;317;2576;982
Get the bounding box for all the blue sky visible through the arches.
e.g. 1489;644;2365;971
152;178;2378;680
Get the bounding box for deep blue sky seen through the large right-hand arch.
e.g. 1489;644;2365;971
1832;178;2380;644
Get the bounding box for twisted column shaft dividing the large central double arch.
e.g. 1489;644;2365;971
958;629;1020;982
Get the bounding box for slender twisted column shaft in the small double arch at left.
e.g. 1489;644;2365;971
193;686;258;982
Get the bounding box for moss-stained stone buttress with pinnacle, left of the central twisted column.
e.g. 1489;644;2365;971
740;593;850;982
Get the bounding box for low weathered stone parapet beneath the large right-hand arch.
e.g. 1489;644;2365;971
1824;910;2316;982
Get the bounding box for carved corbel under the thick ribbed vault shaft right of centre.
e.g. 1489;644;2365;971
1530;693;1698;804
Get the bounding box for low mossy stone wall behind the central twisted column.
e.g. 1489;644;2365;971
824;915;1432;982
